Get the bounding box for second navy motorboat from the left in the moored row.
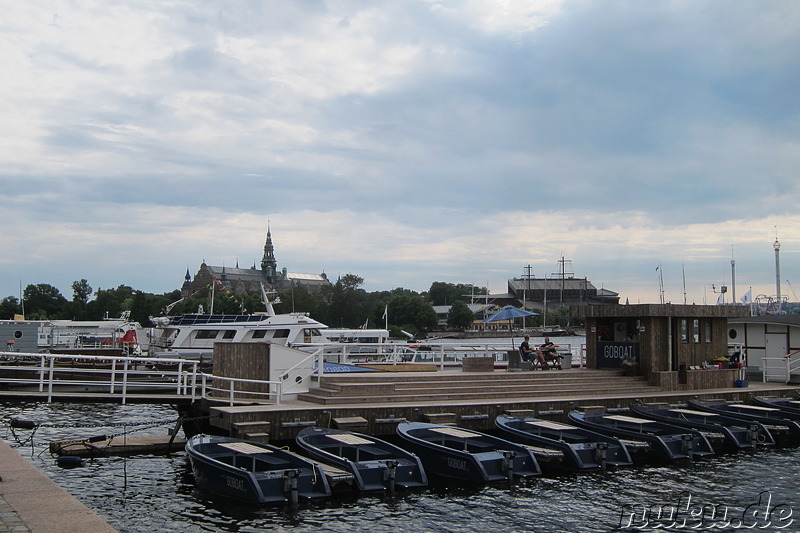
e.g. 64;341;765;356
296;427;428;492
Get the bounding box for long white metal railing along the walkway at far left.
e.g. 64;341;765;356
0;352;200;403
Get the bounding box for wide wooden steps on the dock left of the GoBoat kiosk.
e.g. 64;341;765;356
298;369;660;406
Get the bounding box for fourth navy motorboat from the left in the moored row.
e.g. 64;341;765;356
495;415;633;470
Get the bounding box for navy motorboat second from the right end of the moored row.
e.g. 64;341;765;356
689;399;800;445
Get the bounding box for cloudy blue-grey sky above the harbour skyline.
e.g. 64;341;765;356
0;0;800;304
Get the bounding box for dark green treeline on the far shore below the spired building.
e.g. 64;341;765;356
0;274;506;336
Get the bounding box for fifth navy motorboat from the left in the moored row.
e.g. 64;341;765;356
569;411;714;461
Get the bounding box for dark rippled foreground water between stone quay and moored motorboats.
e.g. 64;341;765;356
2;403;800;533
